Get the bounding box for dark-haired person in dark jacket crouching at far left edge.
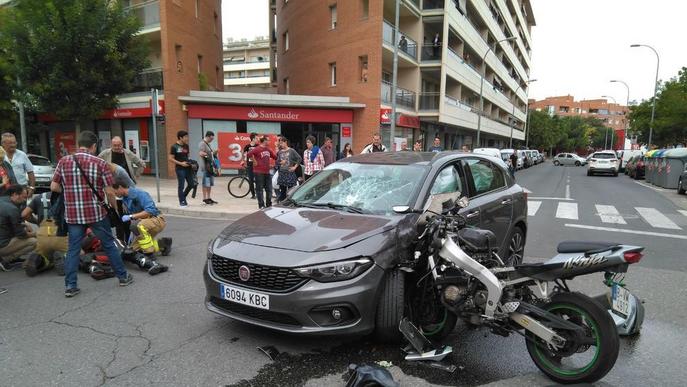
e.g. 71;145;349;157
0;184;36;271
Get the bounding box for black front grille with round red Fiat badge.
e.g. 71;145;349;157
212;255;307;293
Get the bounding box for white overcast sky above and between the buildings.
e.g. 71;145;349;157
222;0;687;104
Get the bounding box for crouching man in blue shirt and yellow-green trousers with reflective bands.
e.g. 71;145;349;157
112;183;172;275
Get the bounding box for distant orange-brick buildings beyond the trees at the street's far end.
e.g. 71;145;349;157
529;95;630;149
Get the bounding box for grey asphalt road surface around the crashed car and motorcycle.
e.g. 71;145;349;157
0;164;687;386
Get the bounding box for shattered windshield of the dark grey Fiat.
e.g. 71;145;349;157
290;163;427;215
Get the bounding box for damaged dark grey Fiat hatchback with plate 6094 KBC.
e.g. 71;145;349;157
203;152;527;335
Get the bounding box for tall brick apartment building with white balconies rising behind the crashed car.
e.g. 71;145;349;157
269;0;535;151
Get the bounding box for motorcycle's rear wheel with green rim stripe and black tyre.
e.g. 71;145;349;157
525;293;620;384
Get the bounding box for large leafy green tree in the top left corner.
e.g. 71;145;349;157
0;0;148;125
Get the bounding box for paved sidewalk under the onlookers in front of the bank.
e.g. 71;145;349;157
137;176;258;219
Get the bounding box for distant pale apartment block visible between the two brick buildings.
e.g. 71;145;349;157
223;36;277;93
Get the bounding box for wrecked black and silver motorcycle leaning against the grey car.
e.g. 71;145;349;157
394;193;644;384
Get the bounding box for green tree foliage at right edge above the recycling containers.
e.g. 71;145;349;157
629;67;687;147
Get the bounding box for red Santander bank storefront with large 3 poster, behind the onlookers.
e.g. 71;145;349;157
179;91;365;169
